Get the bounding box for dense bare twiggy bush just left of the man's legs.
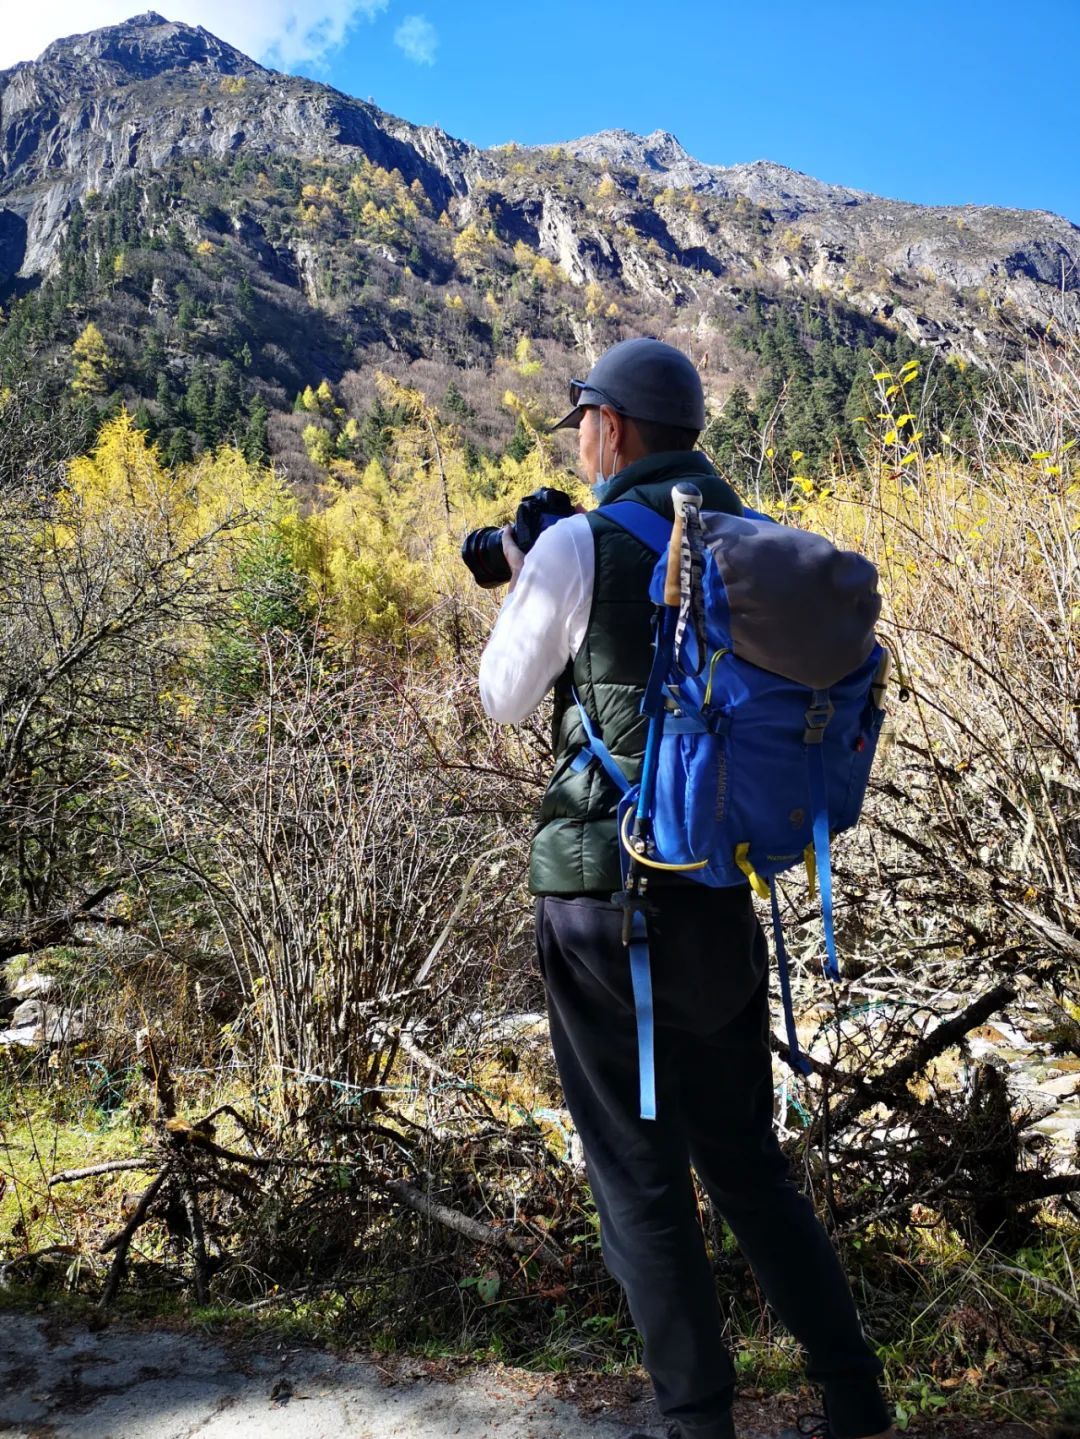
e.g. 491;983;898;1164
125;636;529;1115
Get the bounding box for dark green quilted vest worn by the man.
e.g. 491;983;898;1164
529;450;742;895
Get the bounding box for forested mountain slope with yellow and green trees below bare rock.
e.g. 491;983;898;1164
0;151;984;486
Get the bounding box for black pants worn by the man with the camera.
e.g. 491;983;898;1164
536;886;890;1439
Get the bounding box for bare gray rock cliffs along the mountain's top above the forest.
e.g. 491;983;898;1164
0;12;1080;360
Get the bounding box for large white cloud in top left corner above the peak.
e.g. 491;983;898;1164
0;0;390;69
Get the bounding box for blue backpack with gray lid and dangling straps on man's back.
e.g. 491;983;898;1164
572;484;889;1120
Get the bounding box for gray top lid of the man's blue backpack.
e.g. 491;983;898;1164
702;511;882;689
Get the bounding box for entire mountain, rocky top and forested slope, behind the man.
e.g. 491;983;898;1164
0;12;1080;495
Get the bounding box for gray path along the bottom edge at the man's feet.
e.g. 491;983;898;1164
0;1312;1033;1439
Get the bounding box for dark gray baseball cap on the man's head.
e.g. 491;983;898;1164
548;338;705;433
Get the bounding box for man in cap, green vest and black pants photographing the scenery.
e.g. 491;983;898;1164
480;340;893;1439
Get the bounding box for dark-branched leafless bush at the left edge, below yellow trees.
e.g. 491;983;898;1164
0;471;243;958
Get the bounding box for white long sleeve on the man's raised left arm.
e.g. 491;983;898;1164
480;515;595;724
